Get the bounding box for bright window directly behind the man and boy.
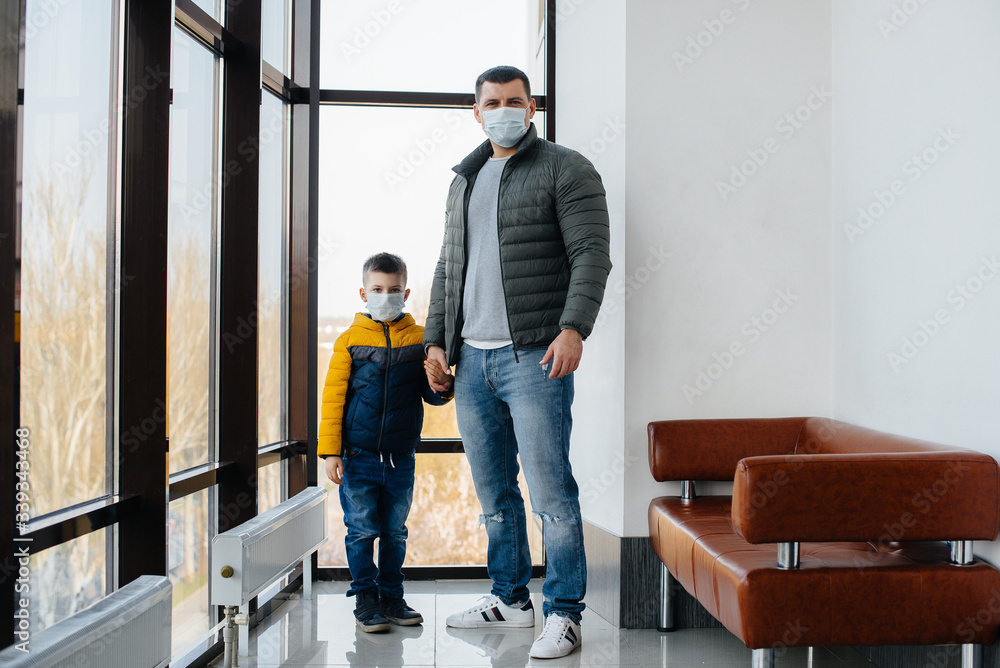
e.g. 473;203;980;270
317;0;546;567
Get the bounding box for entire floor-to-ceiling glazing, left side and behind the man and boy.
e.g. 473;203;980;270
0;0;551;667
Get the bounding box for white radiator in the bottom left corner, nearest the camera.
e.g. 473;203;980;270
0;575;172;668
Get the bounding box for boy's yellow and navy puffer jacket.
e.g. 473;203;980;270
317;313;451;456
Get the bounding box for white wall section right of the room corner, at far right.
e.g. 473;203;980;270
832;0;1000;561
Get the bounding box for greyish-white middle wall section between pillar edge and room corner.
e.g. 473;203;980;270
624;0;833;536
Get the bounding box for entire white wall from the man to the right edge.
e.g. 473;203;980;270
558;0;1000;544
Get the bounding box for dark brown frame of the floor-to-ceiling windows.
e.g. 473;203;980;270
0;0;557;665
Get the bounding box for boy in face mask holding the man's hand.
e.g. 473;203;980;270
317;253;452;632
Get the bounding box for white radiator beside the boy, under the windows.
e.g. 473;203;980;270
212;487;326;607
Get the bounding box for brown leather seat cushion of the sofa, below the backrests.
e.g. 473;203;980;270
649;496;1000;649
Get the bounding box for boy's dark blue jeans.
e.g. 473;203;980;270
340;446;415;598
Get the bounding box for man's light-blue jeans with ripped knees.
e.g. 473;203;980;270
455;345;587;623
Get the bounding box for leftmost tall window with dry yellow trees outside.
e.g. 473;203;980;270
17;0;115;631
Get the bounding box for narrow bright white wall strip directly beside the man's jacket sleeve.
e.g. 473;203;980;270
556;0;626;536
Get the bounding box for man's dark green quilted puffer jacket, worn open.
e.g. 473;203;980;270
424;124;611;364
